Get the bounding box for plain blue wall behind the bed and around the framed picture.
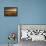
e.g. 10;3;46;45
0;0;46;44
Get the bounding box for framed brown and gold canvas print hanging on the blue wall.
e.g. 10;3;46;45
4;7;18;16
